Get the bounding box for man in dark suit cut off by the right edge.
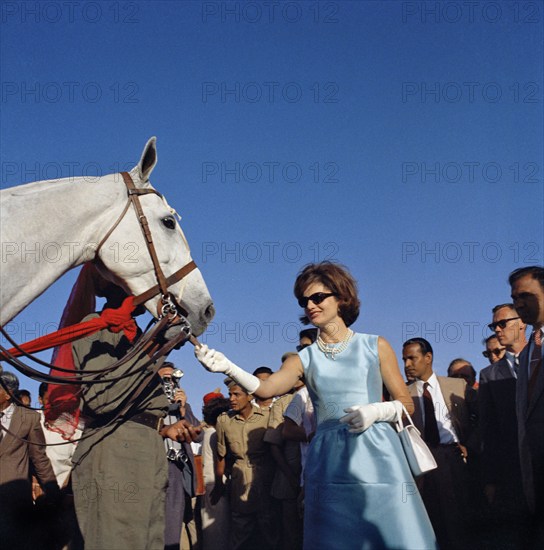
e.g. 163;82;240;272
508;266;544;548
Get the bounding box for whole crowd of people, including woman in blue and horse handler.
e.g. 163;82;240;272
0;262;544;550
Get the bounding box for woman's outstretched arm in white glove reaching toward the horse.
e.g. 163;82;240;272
195;344;303;399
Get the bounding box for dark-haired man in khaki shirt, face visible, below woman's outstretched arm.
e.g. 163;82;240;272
211;382;278;550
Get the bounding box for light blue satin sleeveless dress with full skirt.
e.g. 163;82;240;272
299;334;437;550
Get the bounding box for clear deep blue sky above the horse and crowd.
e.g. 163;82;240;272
0;1;544;410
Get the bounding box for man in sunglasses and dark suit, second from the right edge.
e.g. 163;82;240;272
478;304;527;548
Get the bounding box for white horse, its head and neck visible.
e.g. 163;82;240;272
0;138;214;336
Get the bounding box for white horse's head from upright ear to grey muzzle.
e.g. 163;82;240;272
99;137;215;336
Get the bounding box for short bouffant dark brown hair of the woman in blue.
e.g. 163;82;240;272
294;262;361;327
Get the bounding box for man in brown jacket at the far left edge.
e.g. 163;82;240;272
0;372;60;548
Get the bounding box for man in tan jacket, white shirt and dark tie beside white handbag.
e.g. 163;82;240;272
402;338;476;550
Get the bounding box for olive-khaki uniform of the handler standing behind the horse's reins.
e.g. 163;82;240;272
72;314;168;550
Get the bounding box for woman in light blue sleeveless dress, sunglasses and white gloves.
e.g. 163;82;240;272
195;262;437;550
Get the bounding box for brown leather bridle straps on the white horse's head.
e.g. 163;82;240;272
95;172;196;322
